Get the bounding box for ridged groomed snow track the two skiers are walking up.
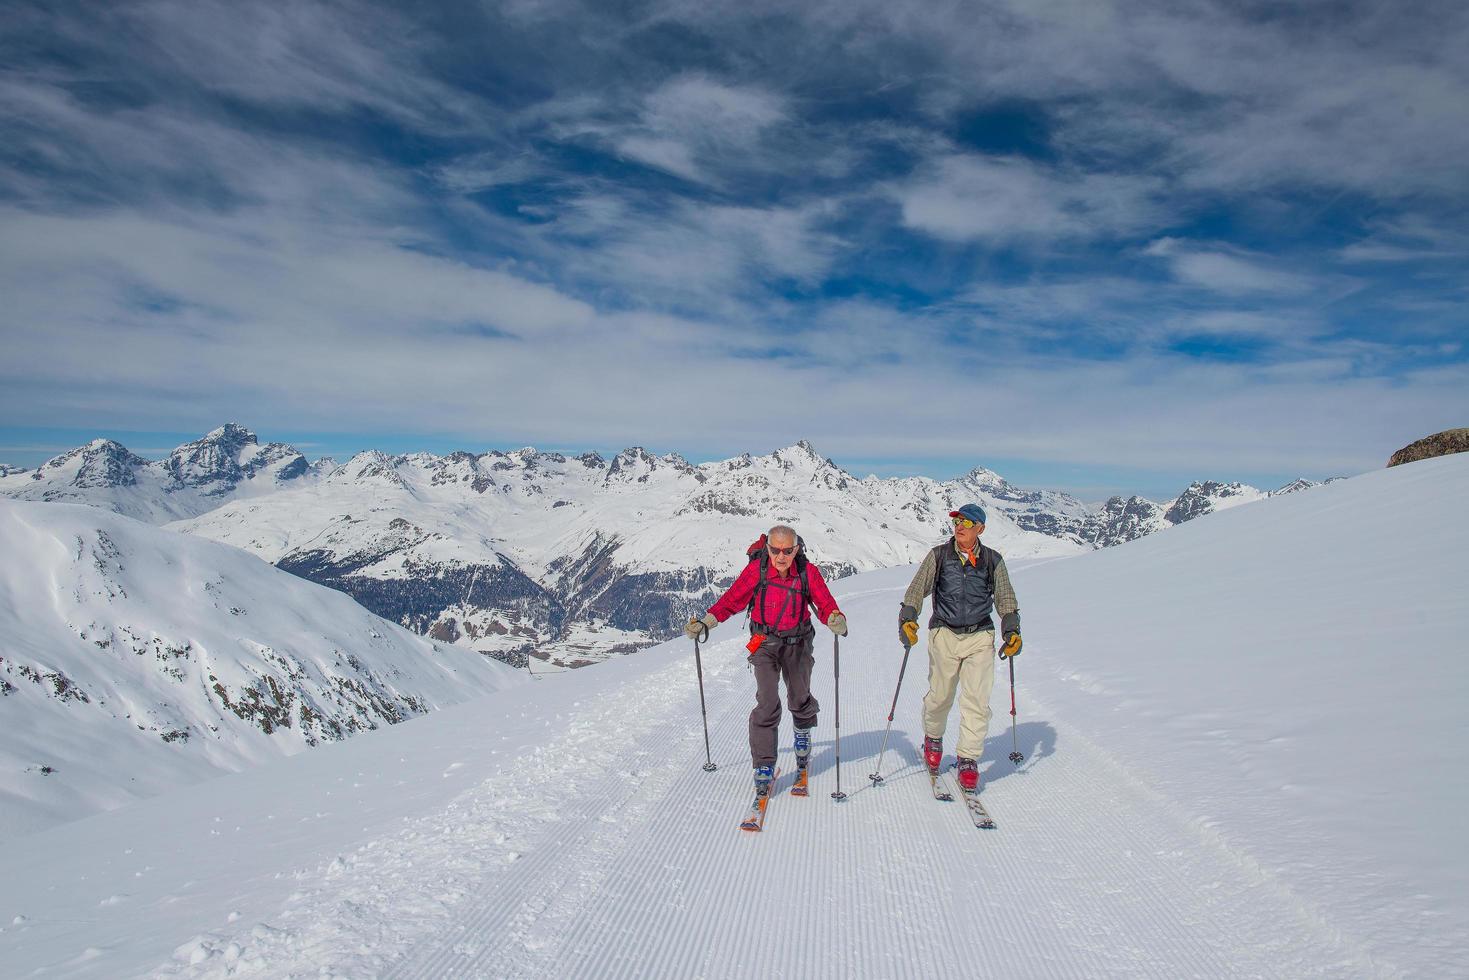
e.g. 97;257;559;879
148;591;1393;980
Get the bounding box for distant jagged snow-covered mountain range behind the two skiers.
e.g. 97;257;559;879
0;423;1339;667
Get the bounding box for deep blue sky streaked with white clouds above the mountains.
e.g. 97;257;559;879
0;0;1469;500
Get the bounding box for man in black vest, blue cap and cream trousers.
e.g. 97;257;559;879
898;504;1021;793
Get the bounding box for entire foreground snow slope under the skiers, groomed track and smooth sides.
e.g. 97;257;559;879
0;457;1469;977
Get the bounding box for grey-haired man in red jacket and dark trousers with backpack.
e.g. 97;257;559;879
685;525;846;796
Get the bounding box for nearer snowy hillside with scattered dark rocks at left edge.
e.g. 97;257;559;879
0;501;521;835
